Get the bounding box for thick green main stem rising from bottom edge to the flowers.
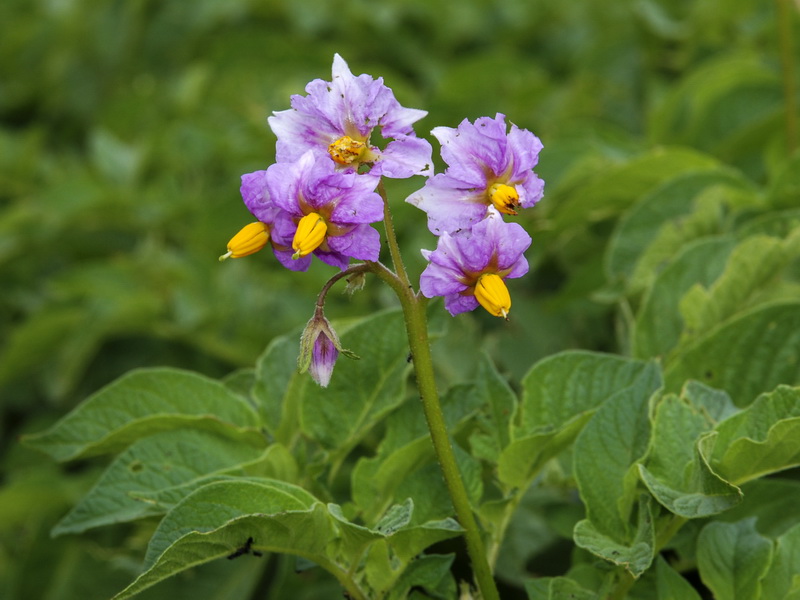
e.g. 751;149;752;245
364;263;500;600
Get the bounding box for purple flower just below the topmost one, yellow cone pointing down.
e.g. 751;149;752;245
242;151;383;271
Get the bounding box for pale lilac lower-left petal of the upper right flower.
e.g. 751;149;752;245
406;173;487;235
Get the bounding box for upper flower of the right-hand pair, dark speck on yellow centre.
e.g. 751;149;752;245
406;113;544;235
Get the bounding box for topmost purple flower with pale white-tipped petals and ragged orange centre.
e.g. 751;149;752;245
268;54;432;178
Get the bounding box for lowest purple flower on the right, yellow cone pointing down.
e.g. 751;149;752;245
419;209;531;317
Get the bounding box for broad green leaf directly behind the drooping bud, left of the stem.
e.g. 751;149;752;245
302;310;410;452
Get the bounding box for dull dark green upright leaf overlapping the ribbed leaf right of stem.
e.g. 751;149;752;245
573;365;661;544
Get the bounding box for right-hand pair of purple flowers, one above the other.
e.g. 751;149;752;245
406;114;544;318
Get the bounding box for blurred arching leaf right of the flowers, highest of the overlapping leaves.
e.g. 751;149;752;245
605;169;748;280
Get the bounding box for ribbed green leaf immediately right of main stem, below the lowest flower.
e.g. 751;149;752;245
498;351;661;487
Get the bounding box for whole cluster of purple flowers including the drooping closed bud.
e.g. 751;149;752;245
220;54;544;386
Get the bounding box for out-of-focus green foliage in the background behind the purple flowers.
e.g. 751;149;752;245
0;0;797;599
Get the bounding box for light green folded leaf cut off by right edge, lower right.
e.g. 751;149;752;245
710;386;800;483
